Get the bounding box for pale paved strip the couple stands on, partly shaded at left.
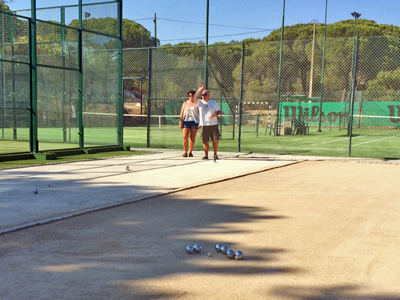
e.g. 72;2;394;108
0;151;301;234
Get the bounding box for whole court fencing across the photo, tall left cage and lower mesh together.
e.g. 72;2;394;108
0;10;400;159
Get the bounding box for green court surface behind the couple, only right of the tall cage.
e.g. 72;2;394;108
124;126;400;158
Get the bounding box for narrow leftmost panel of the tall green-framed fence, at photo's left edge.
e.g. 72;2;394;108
0;13;30;154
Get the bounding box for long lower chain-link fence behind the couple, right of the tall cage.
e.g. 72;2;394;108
124;36;400;159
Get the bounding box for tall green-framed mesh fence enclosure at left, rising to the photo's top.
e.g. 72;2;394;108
0;0;122;154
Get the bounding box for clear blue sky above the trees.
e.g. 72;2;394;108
9;0;400;45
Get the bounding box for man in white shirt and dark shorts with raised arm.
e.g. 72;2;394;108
197;90;221;160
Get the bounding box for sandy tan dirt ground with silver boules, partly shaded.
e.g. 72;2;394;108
0;161;400;300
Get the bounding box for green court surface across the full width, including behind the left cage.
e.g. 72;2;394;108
0;125;400;159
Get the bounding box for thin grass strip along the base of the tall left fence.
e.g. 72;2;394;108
0;151;146;169
